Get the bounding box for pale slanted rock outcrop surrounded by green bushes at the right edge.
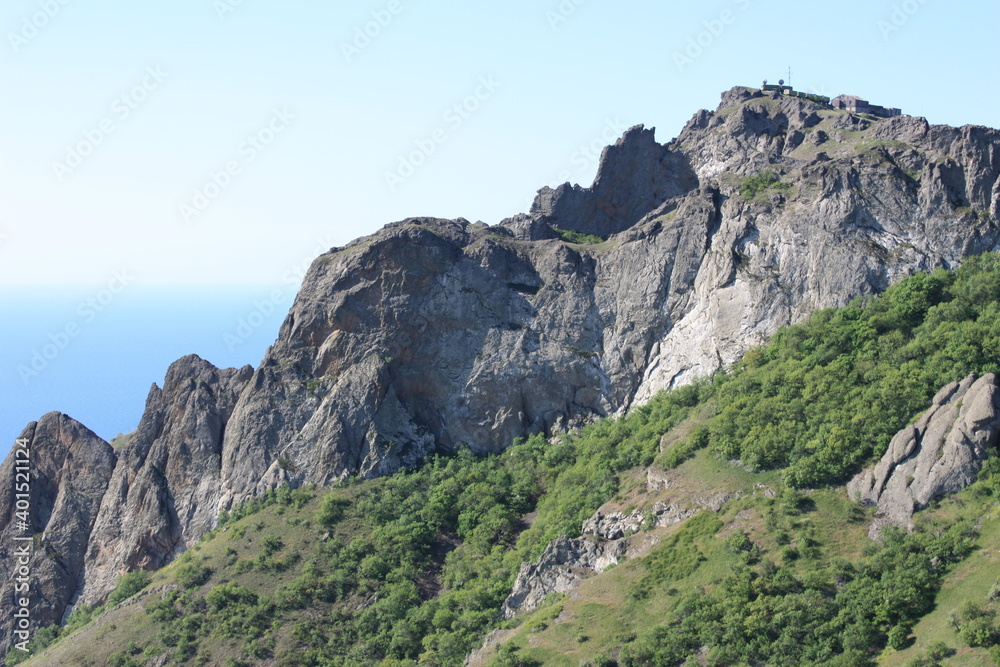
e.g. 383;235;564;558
847;373;1000;539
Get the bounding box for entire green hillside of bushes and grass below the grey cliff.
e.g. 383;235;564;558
17;253;1000;666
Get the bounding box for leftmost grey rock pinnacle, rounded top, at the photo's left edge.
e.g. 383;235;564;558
0;412;117;649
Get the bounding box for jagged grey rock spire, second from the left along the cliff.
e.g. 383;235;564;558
80;356;252;604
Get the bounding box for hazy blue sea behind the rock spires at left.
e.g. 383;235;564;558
0;285;296;457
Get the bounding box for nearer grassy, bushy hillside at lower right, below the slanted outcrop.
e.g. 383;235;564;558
498;460;1000;667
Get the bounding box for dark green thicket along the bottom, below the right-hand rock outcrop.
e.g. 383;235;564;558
619;523;973;667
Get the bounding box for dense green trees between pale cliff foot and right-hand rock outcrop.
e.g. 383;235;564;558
707;255;1000;487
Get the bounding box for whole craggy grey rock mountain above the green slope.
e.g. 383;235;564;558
0;88;1000;652
